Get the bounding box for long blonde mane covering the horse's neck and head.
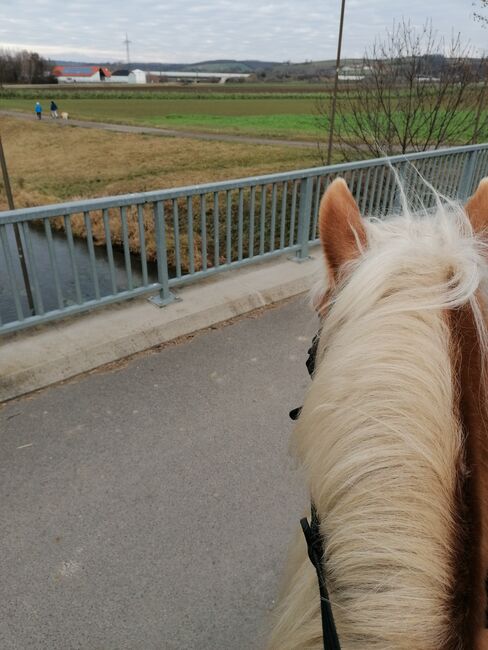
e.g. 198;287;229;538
271;197;488;650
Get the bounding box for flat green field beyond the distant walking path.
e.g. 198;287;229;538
0;85;488;144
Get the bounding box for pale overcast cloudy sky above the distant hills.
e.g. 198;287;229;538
0;0;488;63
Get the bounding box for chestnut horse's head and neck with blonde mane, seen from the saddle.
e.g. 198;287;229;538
271;179;488;650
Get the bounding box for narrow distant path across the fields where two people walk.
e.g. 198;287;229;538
0;110;317;149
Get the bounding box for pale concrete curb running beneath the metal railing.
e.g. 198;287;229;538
0;251;321;402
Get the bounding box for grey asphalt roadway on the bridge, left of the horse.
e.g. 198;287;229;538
0;296;316;650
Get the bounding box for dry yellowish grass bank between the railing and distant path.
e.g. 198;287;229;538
0;117;320;210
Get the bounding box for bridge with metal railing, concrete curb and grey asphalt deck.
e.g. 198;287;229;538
0;145;488;650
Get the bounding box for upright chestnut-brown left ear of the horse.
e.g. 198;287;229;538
319;178;367;281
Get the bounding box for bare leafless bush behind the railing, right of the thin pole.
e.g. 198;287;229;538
318;20;488;160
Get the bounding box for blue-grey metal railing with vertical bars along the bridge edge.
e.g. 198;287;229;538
0;144;488;333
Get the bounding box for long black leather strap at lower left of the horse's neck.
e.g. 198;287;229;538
300;503;341;650
